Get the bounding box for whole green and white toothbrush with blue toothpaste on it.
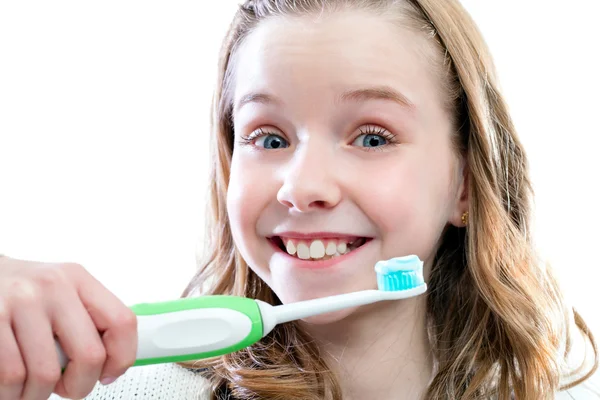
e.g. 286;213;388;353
55;255;427;369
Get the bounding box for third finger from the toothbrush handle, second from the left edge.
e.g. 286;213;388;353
13;297;60;400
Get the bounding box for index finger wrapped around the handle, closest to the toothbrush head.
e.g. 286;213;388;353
66;266;138;379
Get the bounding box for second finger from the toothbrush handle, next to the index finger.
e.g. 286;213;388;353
51;291;106;398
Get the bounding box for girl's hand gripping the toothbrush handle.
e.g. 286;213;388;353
0;256;137;400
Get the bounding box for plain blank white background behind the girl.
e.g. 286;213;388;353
0;0;600;337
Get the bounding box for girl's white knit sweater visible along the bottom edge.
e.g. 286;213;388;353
49;364;600;400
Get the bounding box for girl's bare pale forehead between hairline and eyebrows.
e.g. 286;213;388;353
233;11;440;113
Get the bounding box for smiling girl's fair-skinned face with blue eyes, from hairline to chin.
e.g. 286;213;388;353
227;12;465;323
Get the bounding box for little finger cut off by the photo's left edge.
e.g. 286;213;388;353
0;303;27;400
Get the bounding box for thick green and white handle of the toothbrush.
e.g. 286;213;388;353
56;295;263;368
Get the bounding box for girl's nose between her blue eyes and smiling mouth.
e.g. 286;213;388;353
277;143;342;212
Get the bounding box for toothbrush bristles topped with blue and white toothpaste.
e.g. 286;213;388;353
375;255;426;292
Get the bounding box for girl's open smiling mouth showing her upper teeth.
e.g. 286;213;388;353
268;236;372;261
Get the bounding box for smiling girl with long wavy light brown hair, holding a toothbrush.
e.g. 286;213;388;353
0;0;598;400
